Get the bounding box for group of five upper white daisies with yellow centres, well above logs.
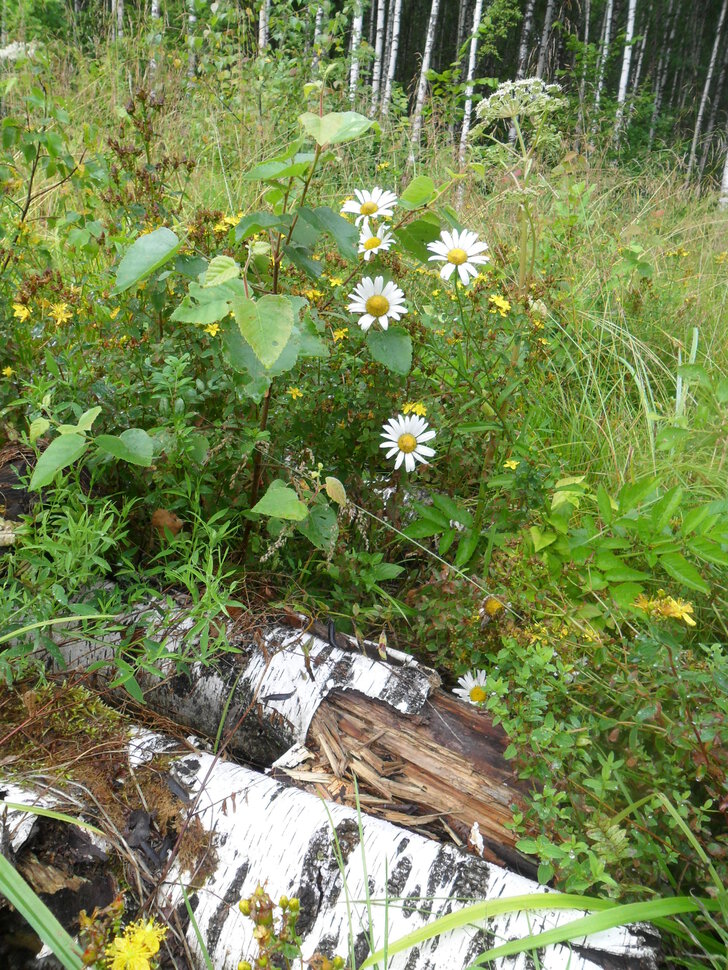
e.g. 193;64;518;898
341;187;488;472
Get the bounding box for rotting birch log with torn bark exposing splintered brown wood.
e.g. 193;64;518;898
52;604;534;875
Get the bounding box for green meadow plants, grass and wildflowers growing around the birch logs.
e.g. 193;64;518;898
0;0;728;967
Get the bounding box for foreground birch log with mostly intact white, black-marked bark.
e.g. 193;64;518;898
0;731;658;970
